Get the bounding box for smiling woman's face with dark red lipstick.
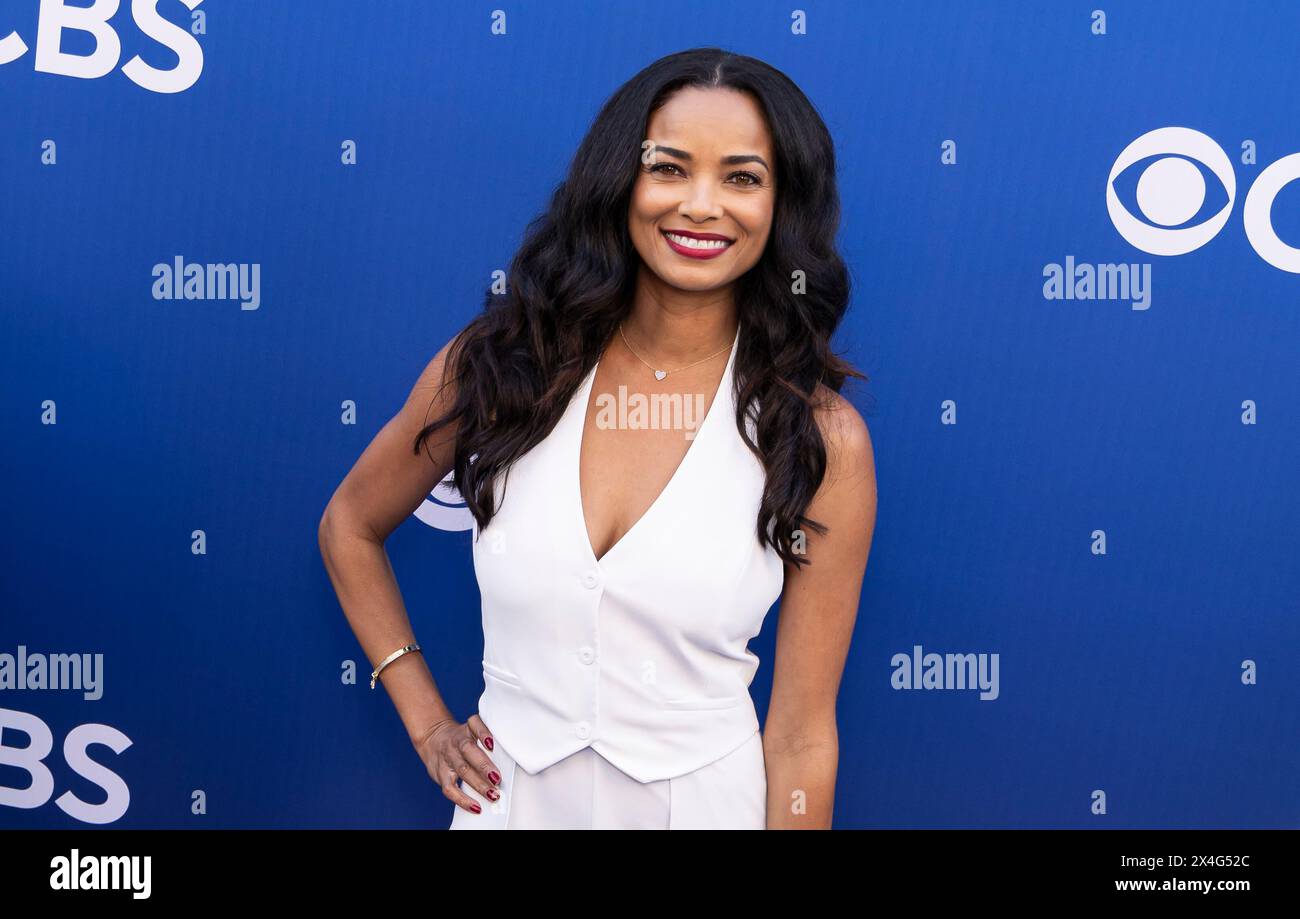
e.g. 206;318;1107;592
628;87;776;290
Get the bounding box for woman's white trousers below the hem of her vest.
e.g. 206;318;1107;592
450;731;767;829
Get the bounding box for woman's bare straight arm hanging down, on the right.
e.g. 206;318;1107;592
763;387;876;829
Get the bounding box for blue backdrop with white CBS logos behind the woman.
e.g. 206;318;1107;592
0;0;1300;828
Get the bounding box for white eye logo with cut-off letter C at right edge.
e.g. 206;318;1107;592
1106;127;1300;273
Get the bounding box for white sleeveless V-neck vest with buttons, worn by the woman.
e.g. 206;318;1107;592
473;323;784;783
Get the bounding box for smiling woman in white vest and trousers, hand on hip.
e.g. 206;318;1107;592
320;48;876;828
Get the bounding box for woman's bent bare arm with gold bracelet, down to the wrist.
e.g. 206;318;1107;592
320;339;456;746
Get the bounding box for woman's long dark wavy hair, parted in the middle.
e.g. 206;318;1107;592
415;48;867;565
